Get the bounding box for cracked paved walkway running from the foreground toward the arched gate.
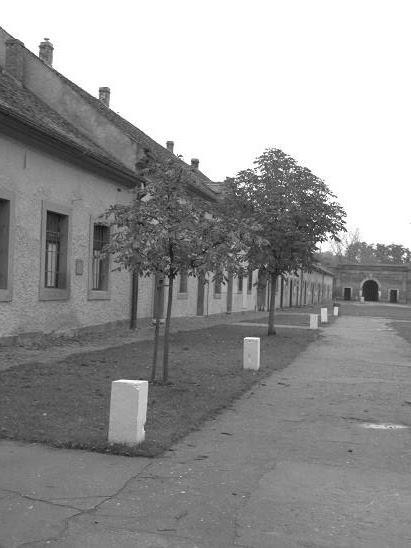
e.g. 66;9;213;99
0;317;411;548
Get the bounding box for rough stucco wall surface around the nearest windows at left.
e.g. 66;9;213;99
0;136;138;337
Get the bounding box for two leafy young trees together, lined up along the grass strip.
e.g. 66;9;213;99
106;149;345;382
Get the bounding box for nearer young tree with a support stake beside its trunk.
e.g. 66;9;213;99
106;157;244;382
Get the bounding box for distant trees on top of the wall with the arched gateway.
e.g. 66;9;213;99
319;229;411;266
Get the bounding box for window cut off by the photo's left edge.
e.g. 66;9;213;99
0;189;14;301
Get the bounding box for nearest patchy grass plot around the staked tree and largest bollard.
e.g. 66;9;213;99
0;325;318;456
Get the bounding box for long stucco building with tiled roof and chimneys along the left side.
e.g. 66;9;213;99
0;28;332;342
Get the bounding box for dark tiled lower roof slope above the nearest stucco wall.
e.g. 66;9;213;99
0;69;138;175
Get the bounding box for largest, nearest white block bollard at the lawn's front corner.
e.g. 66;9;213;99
108;379;148;445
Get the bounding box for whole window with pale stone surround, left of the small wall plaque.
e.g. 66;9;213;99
40;202;70;300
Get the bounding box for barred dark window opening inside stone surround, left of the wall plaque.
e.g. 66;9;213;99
44;211;67;289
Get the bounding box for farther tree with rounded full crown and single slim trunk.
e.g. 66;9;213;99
223;149;345;335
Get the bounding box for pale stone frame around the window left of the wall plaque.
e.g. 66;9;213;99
39;200;73;301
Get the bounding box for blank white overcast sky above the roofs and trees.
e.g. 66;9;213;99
0;0;411;247
